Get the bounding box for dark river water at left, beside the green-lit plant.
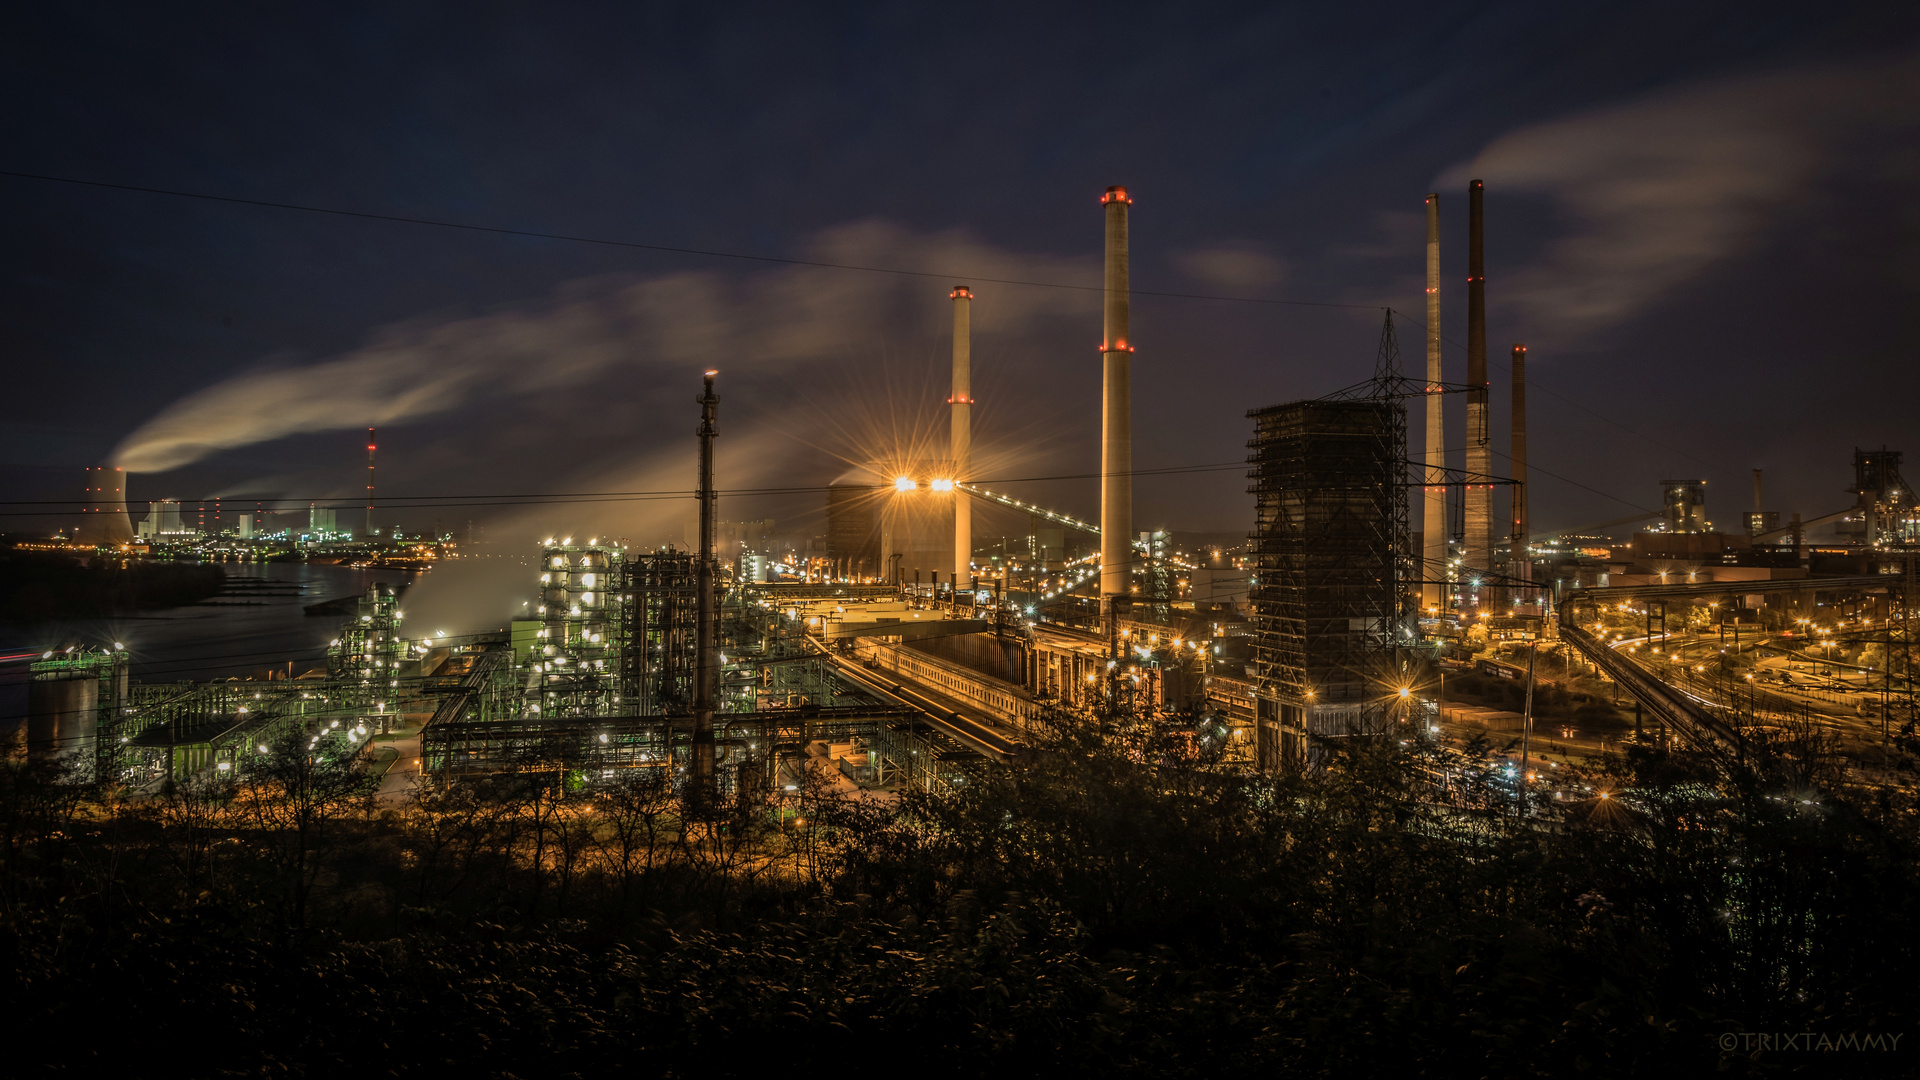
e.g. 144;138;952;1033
0;563;420;723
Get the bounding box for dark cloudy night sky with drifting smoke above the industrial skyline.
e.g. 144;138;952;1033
0;2;1920;542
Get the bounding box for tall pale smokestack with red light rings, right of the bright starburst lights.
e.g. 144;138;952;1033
1100;186;1133;622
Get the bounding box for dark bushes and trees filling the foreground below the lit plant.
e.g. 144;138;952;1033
0;717;1920;1076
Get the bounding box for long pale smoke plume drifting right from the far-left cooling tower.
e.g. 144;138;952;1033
113;221;1100;473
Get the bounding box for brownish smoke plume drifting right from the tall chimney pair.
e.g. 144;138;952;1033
1436;50;1920;331
